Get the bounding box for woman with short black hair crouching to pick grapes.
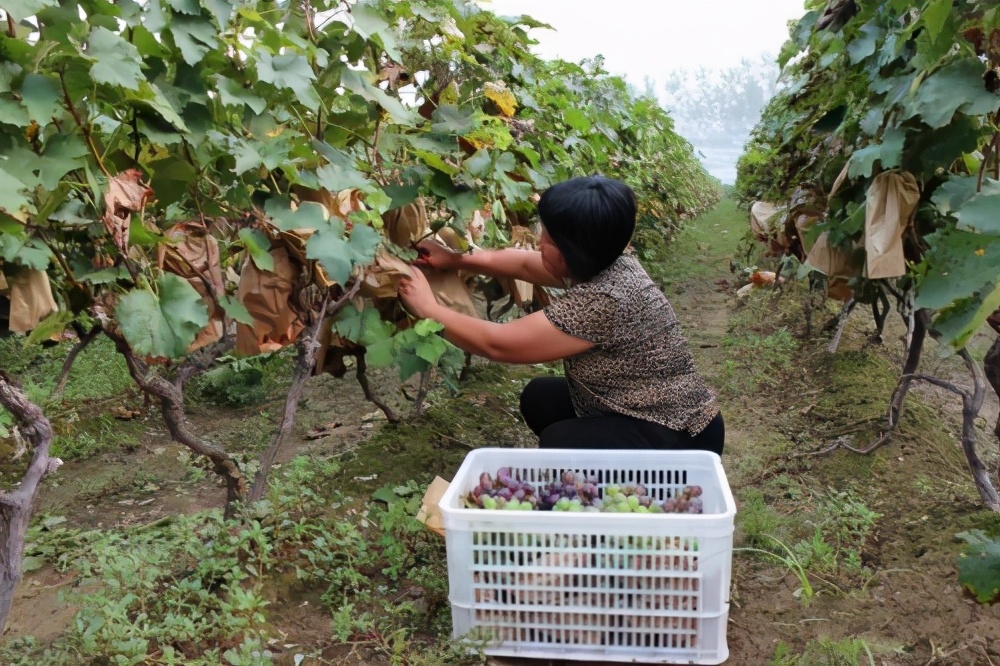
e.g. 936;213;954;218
399;176;725;455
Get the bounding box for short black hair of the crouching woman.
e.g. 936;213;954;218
538;176;635;282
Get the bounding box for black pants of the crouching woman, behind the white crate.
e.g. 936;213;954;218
521;377;726;455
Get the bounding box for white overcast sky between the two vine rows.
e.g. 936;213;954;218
480;0;805;91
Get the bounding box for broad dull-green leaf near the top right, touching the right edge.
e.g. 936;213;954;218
905;58;1000;128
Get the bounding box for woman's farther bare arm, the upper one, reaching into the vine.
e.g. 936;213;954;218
417;240;565;287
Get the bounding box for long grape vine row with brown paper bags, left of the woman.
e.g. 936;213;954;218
0;0;718;636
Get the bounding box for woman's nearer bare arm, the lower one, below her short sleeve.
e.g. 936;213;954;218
399;271;594;363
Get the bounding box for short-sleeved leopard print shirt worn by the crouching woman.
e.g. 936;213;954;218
545;254;719;435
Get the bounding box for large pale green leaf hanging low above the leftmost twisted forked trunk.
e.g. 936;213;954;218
115;273;208;358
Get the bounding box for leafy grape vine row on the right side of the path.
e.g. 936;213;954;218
737;0;1000;511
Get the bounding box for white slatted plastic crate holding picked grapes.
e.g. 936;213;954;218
440;448;736;664
